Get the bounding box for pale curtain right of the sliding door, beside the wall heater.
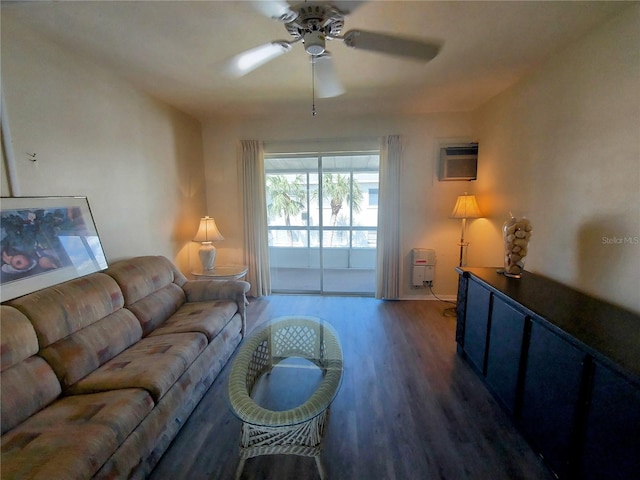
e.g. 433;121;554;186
376;135;402;300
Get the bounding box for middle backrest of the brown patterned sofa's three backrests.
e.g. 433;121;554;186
8;273;142;390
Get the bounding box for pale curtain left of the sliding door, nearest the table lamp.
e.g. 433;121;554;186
240;140;271;297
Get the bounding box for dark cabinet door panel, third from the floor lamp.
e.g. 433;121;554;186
521;321;585;478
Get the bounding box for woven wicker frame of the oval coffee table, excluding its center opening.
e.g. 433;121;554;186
229;317;342;478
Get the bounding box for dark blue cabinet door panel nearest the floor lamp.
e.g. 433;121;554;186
464;282;491;374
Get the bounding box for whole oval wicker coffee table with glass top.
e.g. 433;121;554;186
229;316;342;478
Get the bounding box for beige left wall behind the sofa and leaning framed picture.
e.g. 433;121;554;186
2;15;205;272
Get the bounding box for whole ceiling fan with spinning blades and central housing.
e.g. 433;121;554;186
228;0;441;98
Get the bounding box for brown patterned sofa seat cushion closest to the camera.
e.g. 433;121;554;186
2;389;153;480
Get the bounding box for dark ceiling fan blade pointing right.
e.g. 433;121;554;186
343;30;441;61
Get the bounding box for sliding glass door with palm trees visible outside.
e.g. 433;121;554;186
265;152;379;295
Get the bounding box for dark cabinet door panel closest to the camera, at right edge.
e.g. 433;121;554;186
579;363;640;480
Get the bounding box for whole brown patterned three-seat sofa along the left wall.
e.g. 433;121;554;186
0;256;249;480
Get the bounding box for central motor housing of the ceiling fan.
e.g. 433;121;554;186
285;3;344;56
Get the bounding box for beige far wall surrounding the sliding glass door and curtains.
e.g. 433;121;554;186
204;113;474;298
